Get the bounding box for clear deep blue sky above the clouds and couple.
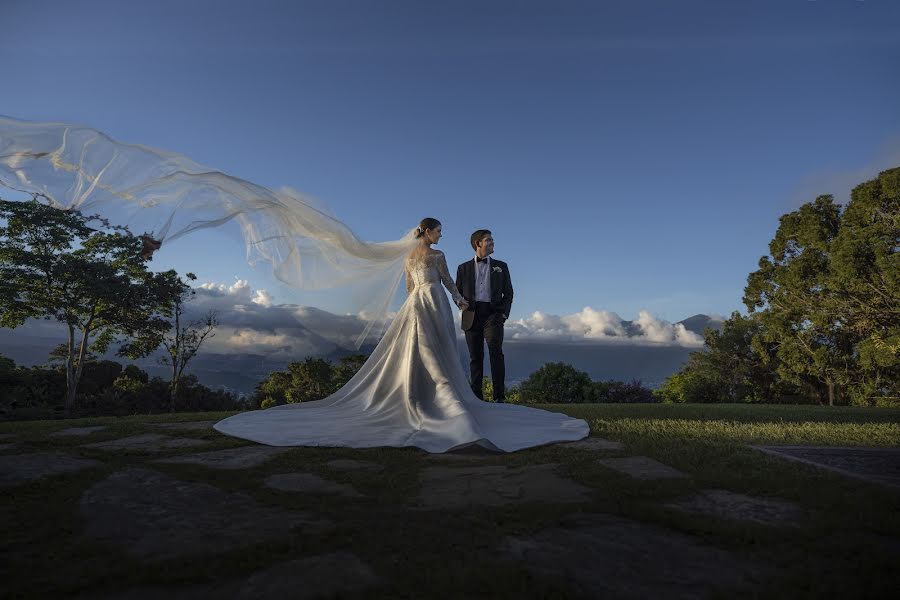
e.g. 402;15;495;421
0;0;900;321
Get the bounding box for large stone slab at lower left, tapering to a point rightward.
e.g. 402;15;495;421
79;468;331;560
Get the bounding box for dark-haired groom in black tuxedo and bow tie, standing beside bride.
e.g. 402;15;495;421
456;229;513;402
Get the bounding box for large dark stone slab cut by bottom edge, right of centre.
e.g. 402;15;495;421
500;514;769;600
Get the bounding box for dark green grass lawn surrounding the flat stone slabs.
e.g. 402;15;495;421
0;405;900;599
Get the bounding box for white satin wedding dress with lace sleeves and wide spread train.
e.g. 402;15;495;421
215;250;590;452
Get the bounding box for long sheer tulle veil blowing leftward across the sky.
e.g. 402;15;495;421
0;116;416;347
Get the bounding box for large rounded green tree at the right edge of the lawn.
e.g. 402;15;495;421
744;169;900;404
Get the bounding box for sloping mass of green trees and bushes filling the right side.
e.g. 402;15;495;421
657;168;900;405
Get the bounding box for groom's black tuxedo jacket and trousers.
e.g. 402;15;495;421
456;258;513;401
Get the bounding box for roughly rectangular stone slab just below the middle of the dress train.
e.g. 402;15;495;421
418;463;592;509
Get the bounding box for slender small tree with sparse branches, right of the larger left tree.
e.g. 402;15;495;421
160;271;219;412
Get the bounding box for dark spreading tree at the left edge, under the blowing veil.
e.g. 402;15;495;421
0;198;181;415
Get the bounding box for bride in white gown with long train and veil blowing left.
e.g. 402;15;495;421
0;116;589;452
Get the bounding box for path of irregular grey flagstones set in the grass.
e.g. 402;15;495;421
0;421;900;600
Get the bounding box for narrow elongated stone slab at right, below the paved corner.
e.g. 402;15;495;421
665;490;803;527
